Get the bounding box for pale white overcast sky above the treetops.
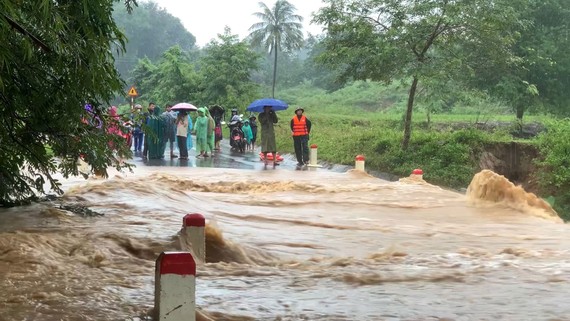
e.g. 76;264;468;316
148;0;324;47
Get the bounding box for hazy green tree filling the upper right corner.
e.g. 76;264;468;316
466;0;570;120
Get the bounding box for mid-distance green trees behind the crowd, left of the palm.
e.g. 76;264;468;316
132;29;259;107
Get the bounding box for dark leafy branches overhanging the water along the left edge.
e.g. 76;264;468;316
0;0;132;206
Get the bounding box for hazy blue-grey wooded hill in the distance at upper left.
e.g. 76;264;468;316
113;1;196;80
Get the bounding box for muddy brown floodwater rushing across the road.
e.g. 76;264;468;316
0;167;570;321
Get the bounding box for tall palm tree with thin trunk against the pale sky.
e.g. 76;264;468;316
249;0;303;98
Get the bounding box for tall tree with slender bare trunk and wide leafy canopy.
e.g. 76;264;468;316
315;0;524;149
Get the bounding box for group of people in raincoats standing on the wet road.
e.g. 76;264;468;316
126;102;312;166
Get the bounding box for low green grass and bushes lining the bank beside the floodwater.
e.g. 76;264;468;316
278;114;506;188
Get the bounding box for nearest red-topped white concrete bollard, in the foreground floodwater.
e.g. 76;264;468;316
154;252;196;321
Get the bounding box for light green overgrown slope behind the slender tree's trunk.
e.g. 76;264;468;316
279;81;510;119
